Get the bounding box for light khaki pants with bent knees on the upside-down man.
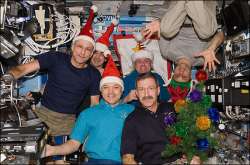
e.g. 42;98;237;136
161;0;217;39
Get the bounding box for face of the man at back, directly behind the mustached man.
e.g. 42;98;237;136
134;58;152;73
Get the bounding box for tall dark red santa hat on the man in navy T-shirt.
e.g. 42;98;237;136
72;5;98;48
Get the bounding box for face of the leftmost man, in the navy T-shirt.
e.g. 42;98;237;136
71;40;94;68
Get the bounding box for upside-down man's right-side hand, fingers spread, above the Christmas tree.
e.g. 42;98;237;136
194;49;220;72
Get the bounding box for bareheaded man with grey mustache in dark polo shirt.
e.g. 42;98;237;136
121;73;200;164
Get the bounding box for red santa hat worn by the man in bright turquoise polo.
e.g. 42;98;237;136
100;50;124;91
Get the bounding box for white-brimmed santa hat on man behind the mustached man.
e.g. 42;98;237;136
132;43;154;62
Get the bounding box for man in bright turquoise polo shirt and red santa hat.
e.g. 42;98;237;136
44;52;134;165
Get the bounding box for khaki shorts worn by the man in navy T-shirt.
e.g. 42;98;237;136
35;106;75;136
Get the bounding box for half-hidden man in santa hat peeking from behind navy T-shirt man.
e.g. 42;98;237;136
90;19;118;74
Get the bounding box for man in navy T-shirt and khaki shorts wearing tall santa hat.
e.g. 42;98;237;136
2;6;101;164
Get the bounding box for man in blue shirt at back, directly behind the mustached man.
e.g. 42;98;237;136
123;44;170;105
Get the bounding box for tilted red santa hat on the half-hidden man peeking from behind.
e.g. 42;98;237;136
96;19;118;52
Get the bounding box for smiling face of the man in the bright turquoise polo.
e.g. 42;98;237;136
101;83;122;105
